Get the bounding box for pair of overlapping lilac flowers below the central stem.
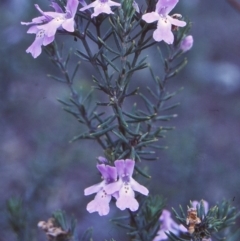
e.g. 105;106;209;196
84;159;148;216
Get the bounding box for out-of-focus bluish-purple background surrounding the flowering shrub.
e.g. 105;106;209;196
0;0;240;241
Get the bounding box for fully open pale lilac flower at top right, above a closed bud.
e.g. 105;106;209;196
142;0;186;44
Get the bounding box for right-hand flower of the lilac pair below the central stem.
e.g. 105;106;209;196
105;159;148;211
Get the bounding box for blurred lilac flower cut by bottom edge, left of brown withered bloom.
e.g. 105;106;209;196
153;209;187;241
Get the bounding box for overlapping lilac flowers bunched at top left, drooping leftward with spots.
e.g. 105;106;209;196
21;0;78;58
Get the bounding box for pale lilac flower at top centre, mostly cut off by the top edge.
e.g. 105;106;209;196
79;0;121;18
